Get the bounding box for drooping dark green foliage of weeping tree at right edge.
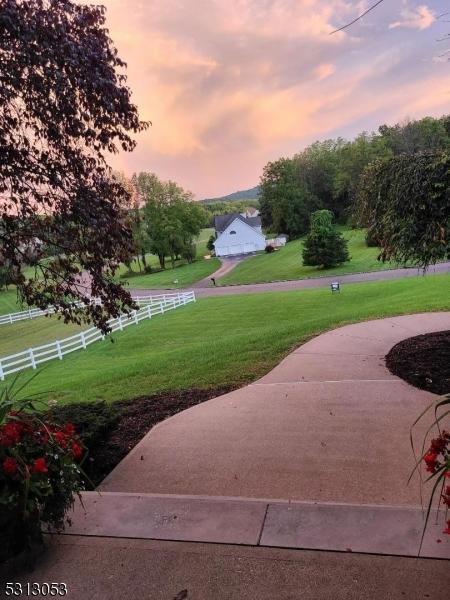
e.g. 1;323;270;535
357;153;450;267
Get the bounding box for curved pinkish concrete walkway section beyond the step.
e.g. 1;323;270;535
101;312;450;505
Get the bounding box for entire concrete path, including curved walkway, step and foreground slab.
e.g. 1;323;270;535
7;312;450;600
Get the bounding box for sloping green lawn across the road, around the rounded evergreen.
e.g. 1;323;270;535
218;227;396;285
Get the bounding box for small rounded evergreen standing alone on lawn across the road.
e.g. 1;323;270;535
303;210;350;268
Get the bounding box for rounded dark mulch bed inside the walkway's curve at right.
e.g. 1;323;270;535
386;331;450;395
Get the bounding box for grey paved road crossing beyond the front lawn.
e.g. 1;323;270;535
130;262;450;298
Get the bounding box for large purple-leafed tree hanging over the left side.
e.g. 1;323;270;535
0;0;148;331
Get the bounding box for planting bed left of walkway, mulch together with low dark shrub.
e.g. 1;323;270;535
50;386;236;487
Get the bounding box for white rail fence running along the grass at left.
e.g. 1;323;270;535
0;292;195;381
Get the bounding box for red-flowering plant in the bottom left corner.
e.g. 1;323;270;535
0;384;85;560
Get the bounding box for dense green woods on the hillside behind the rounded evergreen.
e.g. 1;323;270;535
259;115;450;243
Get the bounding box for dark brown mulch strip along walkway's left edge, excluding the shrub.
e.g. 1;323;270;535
86;386;236;485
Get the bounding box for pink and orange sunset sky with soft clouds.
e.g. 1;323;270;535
102;0;450;198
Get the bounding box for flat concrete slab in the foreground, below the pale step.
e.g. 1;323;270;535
9;536;450;600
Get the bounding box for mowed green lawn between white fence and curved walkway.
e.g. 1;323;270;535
1;275;450;403
